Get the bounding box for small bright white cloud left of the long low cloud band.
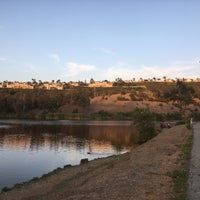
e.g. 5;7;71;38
64;62;96;77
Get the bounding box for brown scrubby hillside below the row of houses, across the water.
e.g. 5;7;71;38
0;82;200;119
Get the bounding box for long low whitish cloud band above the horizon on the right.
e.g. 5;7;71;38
103;58;200;80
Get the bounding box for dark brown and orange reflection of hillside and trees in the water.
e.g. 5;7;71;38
0;125;137;151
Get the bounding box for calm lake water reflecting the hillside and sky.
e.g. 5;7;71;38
0;120;136;190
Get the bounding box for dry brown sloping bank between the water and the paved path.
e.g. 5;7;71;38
0;126;191;200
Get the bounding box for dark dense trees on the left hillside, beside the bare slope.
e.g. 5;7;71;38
0;88;92;114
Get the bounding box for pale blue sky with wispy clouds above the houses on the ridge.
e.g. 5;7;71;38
0;0;200;81
